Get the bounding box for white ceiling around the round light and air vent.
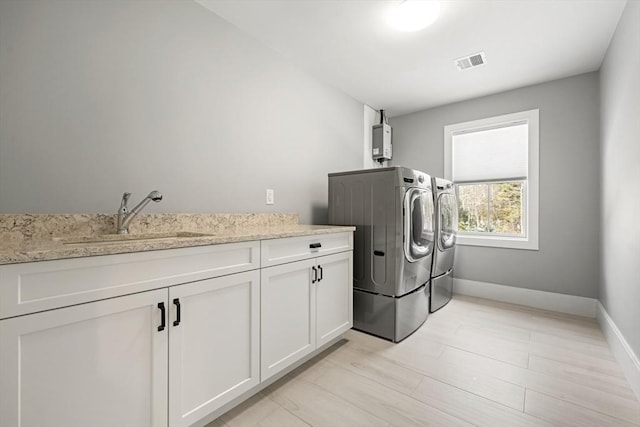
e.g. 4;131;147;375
196;0;625;116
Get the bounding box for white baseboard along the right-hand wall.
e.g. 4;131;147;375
596;301;640;399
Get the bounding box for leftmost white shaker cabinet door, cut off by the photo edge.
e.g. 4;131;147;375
0;289;168;427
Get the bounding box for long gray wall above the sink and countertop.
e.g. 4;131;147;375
0;0;363;223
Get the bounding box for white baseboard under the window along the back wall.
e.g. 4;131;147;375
453;278;598;318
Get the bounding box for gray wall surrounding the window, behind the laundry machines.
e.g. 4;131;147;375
390;73;600;298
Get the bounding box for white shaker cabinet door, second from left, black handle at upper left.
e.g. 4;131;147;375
169;270;260;427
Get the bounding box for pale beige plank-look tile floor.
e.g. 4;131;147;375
208;295;640;427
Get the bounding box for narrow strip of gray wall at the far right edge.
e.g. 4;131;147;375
600;1;640;362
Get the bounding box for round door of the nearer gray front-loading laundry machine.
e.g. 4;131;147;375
404;188;435;262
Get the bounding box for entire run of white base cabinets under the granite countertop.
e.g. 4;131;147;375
0;232;353;427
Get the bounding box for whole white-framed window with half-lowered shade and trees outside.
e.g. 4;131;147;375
444;110;538;250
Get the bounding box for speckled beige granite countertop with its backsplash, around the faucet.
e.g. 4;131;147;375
0;213;355;265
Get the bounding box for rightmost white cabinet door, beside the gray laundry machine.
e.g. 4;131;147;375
315;251;353;347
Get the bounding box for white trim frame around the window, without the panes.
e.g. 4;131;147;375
444;109;540;250
